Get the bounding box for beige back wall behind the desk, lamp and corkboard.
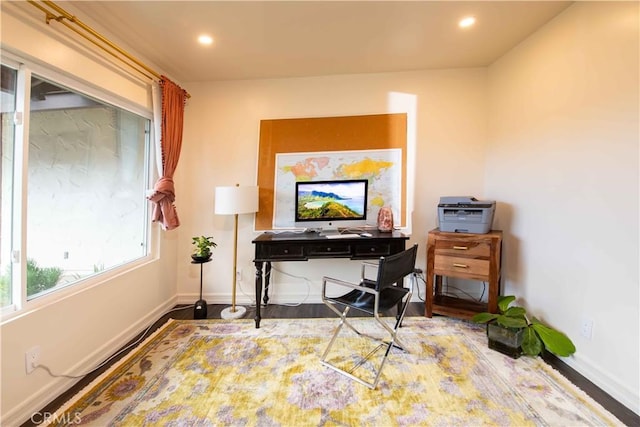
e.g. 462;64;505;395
176;69;486;303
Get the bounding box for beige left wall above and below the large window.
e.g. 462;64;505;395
0;3;177;425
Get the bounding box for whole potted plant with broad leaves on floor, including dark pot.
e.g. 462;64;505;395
471;295;576;358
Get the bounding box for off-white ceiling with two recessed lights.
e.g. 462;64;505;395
63;1;572;83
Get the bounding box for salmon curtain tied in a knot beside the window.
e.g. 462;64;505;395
149;76;187;230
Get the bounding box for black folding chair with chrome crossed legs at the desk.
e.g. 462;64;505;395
321;245;418;389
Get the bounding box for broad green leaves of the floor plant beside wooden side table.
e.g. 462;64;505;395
471;295;576;357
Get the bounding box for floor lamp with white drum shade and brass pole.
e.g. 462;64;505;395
215;184;258;319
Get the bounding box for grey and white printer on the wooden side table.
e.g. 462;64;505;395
438;196;496;234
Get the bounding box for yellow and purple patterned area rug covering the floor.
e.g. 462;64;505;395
51;317;622;427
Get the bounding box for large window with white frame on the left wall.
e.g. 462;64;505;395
0;61;151;306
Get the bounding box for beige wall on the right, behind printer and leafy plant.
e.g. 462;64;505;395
485;2;640;412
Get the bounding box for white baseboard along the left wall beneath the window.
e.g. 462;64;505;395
0;297;177;426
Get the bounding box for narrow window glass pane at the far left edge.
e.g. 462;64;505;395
0;65;17;307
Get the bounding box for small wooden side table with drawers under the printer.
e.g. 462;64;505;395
425;228;502;319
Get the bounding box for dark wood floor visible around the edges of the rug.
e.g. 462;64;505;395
22;302;640;427
